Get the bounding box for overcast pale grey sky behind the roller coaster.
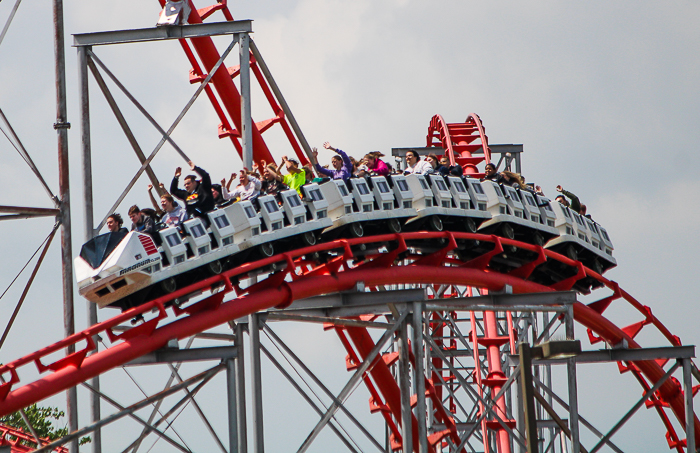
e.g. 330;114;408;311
0;0;700;451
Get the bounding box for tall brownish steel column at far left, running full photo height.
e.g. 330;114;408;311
53;0;78;453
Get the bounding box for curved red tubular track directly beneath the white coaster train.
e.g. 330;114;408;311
0;232;700;451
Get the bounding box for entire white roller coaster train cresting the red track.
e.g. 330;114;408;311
75;170;616;310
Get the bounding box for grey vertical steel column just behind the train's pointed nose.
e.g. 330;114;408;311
78;47;102;453
